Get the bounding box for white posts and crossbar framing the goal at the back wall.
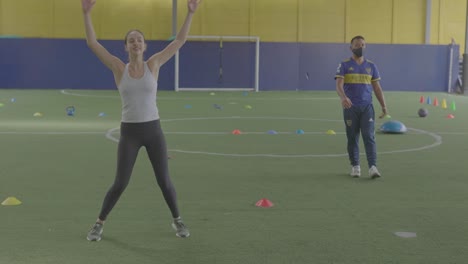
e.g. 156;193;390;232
174;35;260;92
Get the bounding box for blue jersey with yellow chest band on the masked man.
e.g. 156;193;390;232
335;59;380;105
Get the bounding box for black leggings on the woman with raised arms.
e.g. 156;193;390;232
99;120;179;221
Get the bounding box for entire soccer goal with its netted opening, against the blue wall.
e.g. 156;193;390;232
175;36;260;92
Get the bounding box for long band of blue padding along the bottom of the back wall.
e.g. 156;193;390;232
0;38;460;91
